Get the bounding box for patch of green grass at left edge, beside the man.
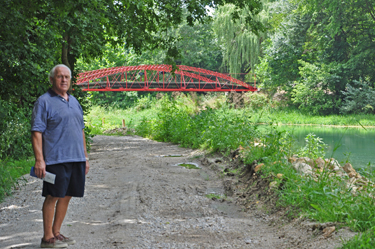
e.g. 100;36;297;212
0;159;35;201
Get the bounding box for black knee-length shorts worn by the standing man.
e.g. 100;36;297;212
42;162;86;197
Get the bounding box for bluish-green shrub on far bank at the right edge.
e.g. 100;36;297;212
340;81;375;114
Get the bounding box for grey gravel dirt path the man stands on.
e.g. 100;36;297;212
0;136;356;248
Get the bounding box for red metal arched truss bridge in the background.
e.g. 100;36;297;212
76;65;257;92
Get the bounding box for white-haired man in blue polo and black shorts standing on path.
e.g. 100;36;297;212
31;64;90;248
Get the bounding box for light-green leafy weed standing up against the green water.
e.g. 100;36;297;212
298;133;327;159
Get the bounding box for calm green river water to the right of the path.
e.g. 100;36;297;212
279;126;375;168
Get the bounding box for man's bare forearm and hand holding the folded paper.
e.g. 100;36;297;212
31;131;46;178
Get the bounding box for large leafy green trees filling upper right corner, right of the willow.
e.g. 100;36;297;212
257;0;375;115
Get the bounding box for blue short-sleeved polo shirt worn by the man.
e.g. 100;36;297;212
31;89;86;165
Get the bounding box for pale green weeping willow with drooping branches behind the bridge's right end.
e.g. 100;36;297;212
213;4;268;80
